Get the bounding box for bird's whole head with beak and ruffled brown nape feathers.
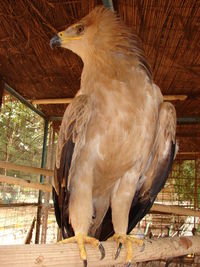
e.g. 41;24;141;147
50;6;151;78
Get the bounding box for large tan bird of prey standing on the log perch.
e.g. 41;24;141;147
50;7;176;266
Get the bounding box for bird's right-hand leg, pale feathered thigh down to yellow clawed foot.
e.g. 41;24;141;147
109;175;144;267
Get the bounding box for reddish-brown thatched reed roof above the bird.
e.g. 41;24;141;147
0;0;200;157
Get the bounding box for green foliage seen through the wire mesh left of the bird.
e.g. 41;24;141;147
0;96;44;203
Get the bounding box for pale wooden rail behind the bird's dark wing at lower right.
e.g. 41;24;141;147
150;203;200;217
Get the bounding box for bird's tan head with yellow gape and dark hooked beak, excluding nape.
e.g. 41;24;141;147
50;6;120;60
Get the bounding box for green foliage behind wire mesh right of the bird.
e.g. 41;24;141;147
172;160;200;207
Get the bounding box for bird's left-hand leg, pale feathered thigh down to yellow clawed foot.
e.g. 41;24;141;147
59;174;105;266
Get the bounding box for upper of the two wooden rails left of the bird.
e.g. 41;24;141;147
0;161;54;176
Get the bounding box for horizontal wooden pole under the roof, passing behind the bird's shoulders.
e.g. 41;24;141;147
31;95;187;105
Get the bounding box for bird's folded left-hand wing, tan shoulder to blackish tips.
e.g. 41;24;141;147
52;95;91;238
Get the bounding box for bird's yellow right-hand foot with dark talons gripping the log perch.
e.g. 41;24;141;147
108;234;144;267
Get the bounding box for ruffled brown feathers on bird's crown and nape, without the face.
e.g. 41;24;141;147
84;7;152;80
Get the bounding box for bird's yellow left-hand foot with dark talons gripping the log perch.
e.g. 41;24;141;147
58;234;105;267
